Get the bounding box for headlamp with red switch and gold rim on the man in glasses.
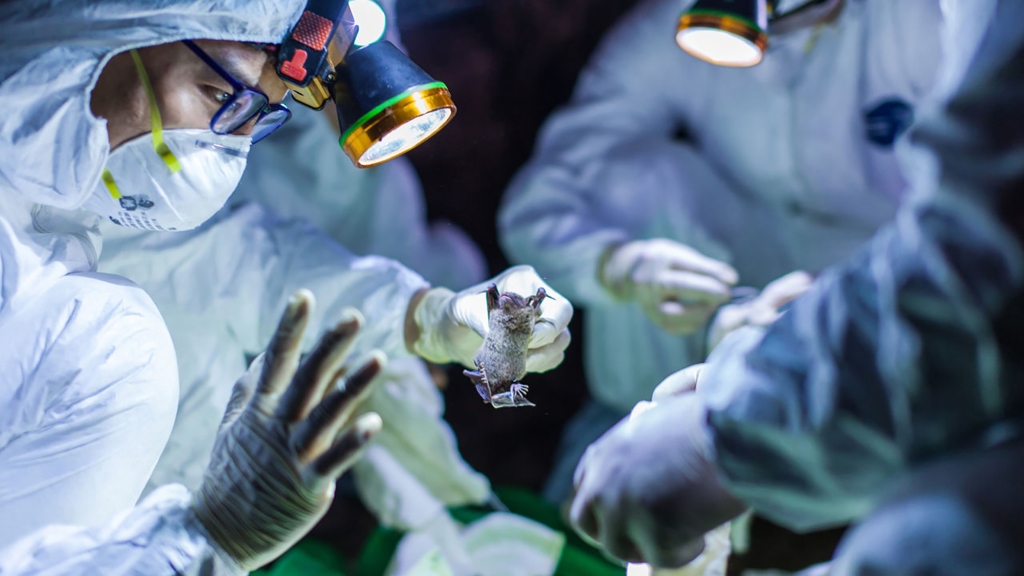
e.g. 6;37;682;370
278;0;456;168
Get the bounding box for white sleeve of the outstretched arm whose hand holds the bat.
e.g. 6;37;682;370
100;204;428;358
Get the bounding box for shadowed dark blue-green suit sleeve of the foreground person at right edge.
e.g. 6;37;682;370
698;0;1024;529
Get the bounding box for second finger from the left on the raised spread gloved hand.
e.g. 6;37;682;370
276;310;362;422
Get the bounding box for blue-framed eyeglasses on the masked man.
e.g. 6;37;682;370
182;40;292;143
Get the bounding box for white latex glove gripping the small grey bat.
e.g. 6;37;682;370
407;265;572;372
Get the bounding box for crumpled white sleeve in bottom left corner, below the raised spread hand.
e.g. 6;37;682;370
0;484;247;576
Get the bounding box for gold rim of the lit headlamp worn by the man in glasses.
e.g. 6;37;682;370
341;82;457;168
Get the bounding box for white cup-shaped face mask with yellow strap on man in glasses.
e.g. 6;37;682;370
82;50;251;231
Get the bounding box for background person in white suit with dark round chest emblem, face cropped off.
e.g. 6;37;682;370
499;0;941;502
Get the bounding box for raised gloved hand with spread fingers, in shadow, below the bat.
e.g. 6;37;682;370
193;290;385;570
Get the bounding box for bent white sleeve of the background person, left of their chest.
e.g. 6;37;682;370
499;0;711;303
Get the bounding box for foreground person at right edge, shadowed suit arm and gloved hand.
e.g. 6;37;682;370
571;0;1024;576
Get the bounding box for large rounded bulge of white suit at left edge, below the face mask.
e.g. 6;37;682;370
0;274;178;547
